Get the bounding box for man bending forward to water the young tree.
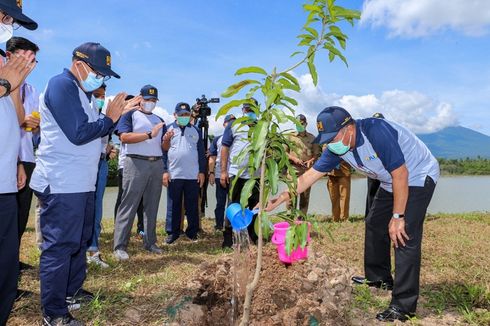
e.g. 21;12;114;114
266;107;439;321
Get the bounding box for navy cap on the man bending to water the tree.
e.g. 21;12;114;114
314;106;352;144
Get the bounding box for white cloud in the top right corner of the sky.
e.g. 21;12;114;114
361;0;490;37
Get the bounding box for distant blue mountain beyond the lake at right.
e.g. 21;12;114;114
417;126;490;159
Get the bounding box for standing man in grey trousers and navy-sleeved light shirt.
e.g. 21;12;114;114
114;85;167;260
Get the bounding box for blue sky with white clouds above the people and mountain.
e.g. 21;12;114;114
15;0;490;135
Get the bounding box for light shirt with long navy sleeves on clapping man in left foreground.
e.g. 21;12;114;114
30;70;113;194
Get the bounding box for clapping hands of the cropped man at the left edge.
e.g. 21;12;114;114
0;51;36;96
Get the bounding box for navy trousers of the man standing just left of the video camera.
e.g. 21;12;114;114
165;179;199;239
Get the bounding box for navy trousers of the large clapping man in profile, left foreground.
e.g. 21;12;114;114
35;187;95;317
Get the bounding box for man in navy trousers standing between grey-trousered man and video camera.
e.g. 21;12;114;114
163;102;206;244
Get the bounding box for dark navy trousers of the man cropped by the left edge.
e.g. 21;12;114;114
0;193;19;326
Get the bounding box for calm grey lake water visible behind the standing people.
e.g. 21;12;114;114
100;176;490;218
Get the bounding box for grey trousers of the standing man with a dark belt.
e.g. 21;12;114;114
114;157;163;250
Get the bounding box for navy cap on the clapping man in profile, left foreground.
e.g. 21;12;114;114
73;42;121;78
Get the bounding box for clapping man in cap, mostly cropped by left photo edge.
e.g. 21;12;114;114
0;0;37;325
